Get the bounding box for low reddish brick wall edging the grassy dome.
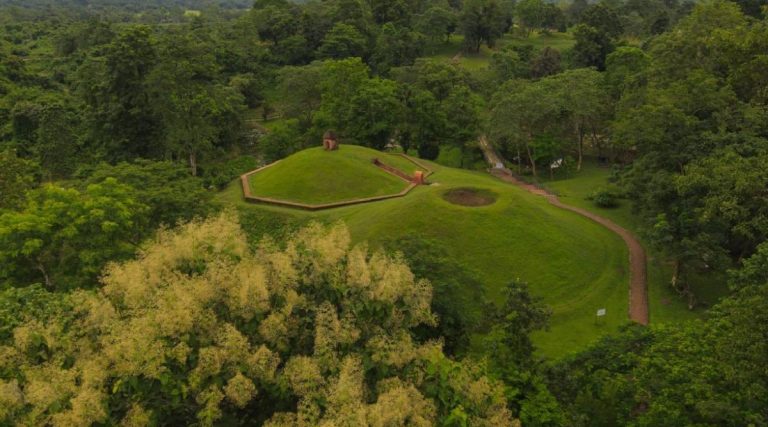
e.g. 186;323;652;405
240;153;433;211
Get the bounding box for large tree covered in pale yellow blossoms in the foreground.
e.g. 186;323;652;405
0;214;514;427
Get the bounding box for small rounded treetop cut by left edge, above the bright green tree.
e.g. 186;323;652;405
0;149;39;211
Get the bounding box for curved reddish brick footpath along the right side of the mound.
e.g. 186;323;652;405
479;137;649;325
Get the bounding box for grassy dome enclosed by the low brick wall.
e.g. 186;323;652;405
250;145;415;204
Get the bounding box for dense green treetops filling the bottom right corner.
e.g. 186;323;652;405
550;272;768;425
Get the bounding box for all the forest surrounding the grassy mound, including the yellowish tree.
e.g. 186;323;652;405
0;0;768;426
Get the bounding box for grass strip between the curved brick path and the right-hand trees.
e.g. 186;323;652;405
545;162;726;323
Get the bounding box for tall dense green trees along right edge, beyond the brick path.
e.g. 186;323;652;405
612;2;765;300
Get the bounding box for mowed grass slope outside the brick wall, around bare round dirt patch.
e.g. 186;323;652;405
217;146;629;358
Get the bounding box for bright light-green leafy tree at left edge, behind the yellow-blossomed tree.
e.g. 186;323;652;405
0;178;146;290
